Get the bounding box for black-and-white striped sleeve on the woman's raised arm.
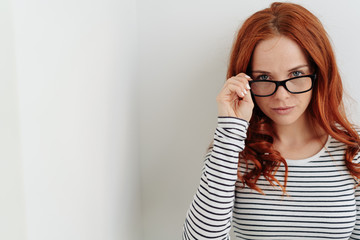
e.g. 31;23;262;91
183;117;248;240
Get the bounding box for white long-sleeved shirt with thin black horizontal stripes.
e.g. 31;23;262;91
182;117;360;240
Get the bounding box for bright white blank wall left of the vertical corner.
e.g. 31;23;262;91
4;0;140;240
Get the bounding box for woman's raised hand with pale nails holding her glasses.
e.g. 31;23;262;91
216;73;254;122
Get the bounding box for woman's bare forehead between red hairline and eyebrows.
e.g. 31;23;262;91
251;36;308;73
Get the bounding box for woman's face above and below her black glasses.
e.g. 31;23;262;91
251;36;313;125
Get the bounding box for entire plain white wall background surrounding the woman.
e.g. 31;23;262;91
0;0;360;240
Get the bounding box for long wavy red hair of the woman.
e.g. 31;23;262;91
227;2;360;193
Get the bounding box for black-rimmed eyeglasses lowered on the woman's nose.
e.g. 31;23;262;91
249;74;316;97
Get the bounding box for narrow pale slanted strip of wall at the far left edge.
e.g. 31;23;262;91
0;0;26;240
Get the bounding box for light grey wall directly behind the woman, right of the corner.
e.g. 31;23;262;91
138;0;360;240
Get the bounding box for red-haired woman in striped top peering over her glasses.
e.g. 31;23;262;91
183;3;360;239
